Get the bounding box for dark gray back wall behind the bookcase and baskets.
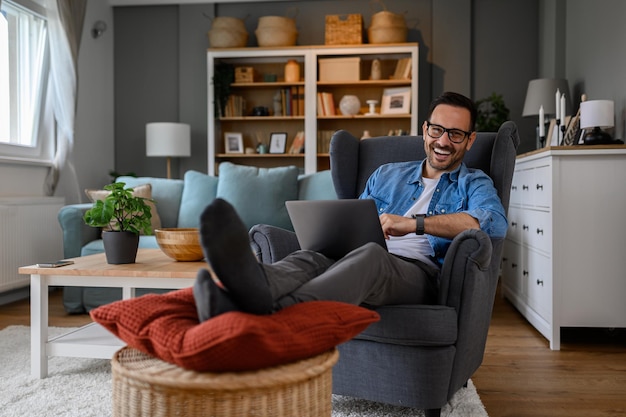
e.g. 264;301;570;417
114;0;538;178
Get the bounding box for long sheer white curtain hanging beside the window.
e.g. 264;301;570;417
43;0;87;195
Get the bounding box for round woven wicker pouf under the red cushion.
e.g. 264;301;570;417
111;347;339;417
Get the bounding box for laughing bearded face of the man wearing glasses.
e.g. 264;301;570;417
422;104;476;178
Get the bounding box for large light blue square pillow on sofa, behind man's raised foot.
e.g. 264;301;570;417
217;162;298;230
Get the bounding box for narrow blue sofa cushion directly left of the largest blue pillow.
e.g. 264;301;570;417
178;171;218;228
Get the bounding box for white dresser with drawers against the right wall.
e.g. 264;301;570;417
502;146;626;350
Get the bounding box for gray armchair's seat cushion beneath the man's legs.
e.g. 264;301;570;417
356;305;458;346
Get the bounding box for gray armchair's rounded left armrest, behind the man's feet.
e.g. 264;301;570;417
249;224;300;264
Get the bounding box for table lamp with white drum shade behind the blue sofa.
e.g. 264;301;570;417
146;123;191;179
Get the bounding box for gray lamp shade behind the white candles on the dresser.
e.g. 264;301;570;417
522;78;571;117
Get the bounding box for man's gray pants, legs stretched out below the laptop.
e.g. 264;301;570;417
263;243;439;311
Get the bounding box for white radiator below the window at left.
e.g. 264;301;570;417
0;197;65;293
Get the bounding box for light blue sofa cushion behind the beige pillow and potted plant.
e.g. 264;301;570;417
116;176;183;227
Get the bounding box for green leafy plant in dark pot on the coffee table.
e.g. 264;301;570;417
83;182;152;264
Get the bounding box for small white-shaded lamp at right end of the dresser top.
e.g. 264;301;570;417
580;100;615;145
